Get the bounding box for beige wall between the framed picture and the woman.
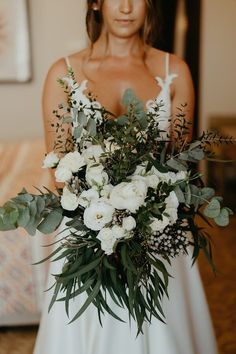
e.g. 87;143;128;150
0;0;86;142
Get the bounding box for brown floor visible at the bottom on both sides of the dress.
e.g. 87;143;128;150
0;218;236;354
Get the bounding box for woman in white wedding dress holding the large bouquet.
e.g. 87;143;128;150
34;0;217;354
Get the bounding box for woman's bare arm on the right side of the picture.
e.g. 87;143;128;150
170;55;195;140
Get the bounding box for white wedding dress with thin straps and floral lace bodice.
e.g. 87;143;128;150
33;54;217;354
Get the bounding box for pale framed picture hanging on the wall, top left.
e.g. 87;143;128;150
0;0;31;83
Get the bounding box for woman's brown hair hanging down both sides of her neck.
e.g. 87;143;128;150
86;0;159;45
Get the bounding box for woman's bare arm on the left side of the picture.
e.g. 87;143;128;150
42;58;70;188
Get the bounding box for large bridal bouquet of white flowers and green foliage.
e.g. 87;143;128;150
0;71;232;334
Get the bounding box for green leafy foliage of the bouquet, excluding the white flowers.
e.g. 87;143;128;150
0;72;233;335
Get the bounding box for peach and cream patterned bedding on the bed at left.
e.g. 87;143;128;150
0;140;53;326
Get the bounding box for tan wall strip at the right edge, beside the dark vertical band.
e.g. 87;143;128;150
200;0;236;130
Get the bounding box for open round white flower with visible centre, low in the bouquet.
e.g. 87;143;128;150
84;199;114;231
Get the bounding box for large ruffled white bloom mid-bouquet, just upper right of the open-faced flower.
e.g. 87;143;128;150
110;180;147;213
